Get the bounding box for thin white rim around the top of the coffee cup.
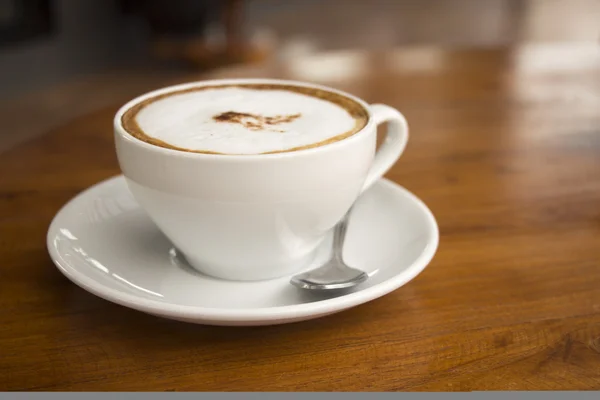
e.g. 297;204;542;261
113;78;374;161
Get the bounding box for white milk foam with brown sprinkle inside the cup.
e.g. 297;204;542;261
135;86;357;154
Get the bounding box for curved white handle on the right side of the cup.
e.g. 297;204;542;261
361;104;408;193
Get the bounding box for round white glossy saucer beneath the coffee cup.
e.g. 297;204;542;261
48;176;439;325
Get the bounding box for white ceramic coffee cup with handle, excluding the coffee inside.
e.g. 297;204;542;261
114;79;408;280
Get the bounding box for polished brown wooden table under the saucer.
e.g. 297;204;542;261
0;45;600;391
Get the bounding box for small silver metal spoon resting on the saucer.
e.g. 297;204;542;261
290;211;369;290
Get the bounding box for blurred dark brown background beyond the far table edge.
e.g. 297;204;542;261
0;0;600;151
